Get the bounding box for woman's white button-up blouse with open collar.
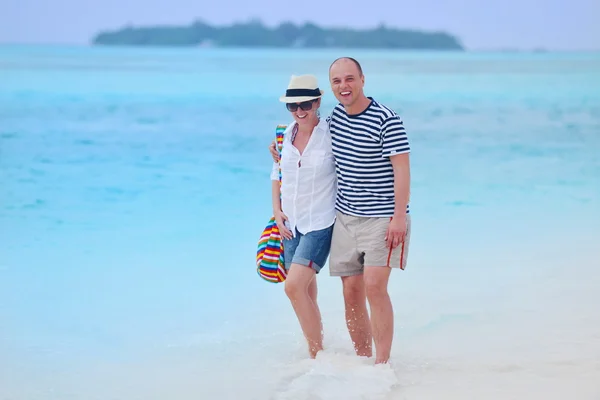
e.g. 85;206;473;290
271;118;337;236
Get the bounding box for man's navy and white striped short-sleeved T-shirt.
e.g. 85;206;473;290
328;97;410;217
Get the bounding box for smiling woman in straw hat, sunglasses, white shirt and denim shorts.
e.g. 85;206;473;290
271;75;336;358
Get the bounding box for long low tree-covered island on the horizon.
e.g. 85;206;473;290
92;20;464;51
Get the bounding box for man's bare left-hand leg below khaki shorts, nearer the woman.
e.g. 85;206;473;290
342;275;373;357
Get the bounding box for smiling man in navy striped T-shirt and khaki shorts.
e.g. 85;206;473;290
271;57;410;364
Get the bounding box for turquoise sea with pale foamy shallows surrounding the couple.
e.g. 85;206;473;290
0;46;600;400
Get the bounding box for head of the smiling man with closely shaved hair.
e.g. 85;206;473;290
329;59;365;107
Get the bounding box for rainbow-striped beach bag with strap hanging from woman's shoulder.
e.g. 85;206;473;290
256;125;287;283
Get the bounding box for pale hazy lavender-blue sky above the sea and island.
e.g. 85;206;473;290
0;0;600;51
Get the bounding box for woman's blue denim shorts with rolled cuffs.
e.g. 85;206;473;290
283;225;333;274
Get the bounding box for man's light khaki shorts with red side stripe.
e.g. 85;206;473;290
329;211;410;276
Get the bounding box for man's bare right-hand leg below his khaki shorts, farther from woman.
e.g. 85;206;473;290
364;267;394;364
